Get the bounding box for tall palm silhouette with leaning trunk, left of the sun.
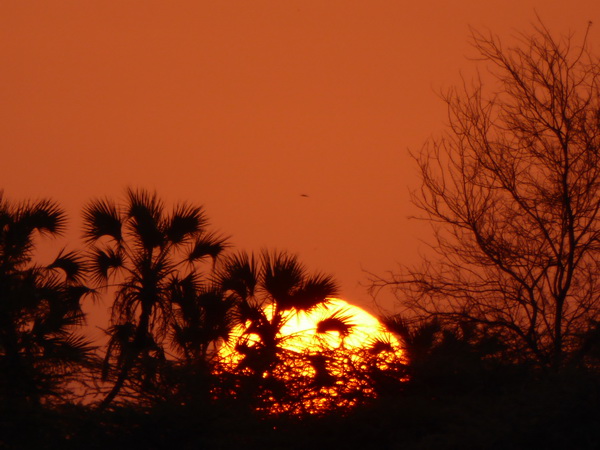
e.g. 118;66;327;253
84;189;226;409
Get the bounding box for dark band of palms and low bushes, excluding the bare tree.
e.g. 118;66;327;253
0;190;600;449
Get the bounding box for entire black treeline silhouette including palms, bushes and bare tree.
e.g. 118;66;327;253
0;23;600;449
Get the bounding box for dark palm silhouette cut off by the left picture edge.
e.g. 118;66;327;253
0;192;92;410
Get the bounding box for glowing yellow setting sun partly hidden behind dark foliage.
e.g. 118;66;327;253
214;298;404;414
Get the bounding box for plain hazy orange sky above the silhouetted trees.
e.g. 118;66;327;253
0;0;600;316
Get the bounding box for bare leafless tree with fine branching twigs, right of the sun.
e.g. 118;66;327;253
373;22;600;367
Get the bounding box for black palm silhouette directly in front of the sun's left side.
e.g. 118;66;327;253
218;251;338;410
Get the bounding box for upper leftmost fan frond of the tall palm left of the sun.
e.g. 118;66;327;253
83;199;123;243
